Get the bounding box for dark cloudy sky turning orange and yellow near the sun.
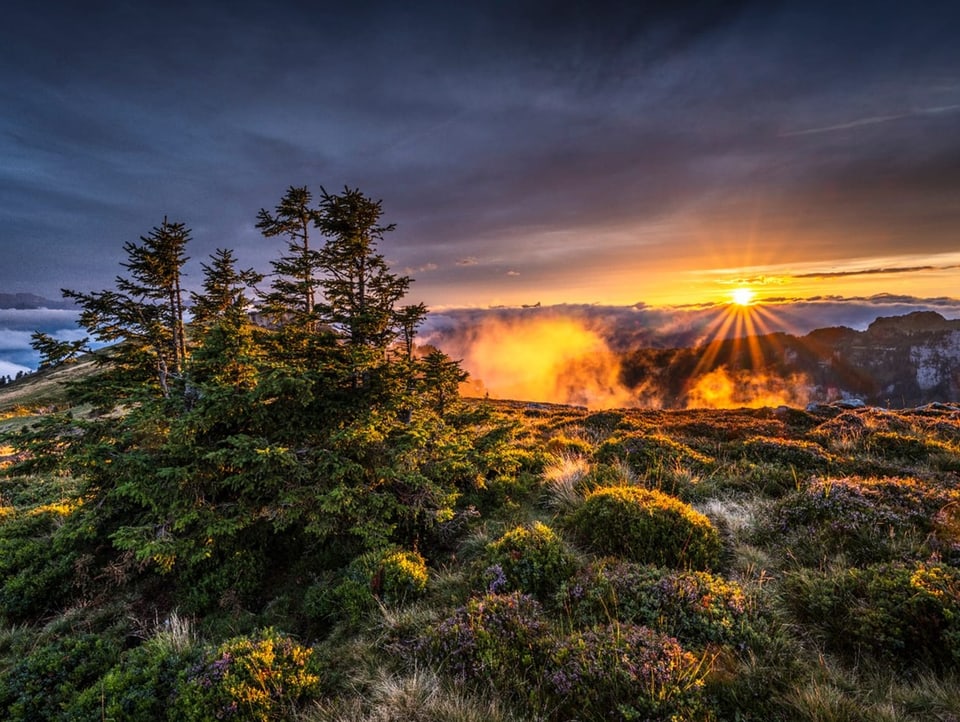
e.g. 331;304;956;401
0;0;960;376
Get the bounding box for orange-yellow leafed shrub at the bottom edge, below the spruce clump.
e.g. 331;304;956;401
174;629;320;722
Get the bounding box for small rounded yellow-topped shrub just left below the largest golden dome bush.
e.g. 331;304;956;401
487;522;574;599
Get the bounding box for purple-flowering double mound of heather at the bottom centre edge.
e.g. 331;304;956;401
424;593;704;721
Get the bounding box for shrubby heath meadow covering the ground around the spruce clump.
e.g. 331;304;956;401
0;372;960;722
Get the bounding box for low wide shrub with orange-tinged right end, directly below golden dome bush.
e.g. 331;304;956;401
558;560;756;648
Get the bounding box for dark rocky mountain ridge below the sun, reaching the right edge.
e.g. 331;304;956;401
621;311;960;408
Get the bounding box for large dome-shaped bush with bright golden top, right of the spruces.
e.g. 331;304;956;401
570;486;721;570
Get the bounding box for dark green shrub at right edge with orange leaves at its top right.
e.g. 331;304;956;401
788;563;960;668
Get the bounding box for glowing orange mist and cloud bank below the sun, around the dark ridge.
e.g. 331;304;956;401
420;295;960;408
